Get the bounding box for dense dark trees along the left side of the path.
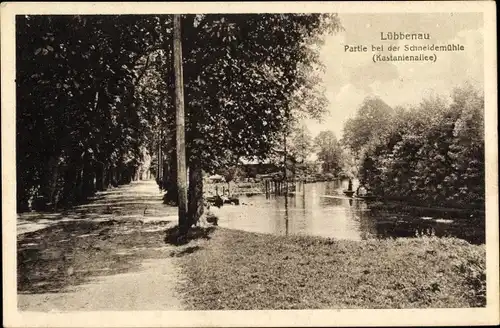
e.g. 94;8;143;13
16;15;168;210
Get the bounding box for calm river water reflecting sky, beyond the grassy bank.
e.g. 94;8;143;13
216;181;484;243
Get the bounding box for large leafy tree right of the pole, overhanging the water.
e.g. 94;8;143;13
166;14;339;228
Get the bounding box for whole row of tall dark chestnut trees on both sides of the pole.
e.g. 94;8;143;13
16;14;339;220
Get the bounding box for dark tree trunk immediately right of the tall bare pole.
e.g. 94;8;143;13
188;159;203;226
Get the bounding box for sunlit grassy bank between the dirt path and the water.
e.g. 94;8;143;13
173;228;485;310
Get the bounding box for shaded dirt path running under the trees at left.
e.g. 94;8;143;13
17;181;187;311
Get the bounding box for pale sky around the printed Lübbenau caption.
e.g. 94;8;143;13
306;13;484;139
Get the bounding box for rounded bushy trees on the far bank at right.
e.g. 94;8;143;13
343;84;485;208
